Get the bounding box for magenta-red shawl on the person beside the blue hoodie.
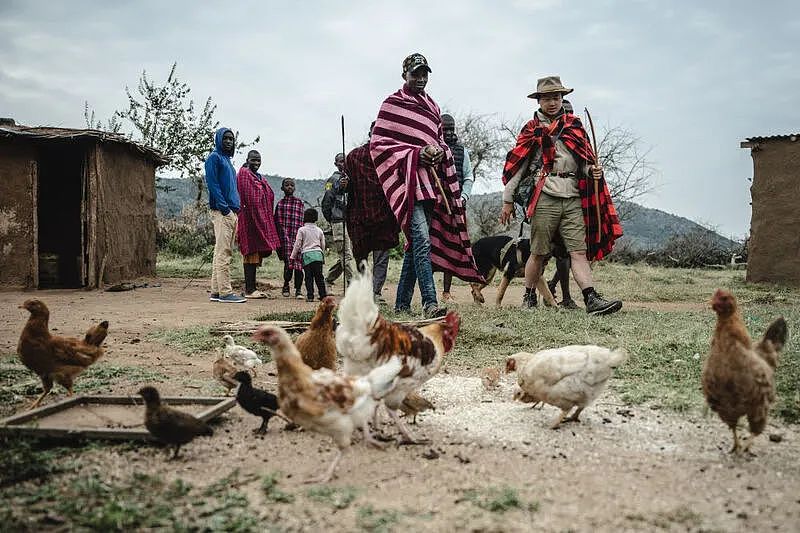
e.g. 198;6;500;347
236;166;281;255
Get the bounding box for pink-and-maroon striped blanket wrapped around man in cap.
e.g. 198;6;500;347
369;85;483;282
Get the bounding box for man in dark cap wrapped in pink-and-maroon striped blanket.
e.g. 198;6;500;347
369;54;482;318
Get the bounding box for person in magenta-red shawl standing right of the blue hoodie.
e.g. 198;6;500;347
236;150;280;298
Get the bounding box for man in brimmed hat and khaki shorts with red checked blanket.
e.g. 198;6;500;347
500;76;622;315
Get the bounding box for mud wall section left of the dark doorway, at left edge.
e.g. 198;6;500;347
0;139;38;288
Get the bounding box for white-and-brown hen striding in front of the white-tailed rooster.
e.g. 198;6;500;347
253;326;402;482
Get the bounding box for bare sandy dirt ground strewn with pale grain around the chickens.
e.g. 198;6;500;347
0;280;800;531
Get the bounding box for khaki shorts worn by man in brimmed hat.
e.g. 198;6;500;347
531;192;586;255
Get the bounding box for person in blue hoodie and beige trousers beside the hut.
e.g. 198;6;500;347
206;128;247;303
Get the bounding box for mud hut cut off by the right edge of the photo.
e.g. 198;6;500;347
741;133;800;284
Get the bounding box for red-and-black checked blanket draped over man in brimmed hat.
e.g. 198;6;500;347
503;113;622;261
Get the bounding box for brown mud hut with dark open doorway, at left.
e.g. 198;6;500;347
0;118;167;288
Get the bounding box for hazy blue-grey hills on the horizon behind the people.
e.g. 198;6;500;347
156;175;740;249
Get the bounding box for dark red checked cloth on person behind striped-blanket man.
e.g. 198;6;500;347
345;143;400;258
